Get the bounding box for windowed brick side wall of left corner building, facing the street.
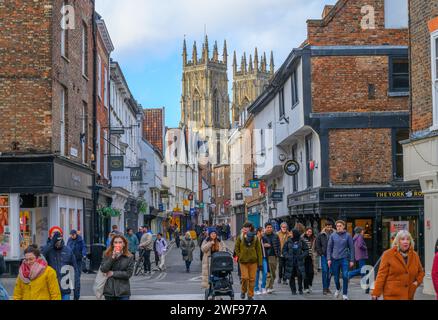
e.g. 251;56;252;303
52;0;93;164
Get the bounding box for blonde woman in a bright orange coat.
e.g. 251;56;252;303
372;230;424;300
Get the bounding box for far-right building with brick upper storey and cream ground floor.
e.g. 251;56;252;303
403;0;438;294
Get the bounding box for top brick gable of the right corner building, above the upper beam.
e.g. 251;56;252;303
307;0;408;46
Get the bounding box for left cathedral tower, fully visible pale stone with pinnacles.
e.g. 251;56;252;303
181;36;230;131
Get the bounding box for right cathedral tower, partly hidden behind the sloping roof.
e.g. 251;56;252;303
232;48;274;122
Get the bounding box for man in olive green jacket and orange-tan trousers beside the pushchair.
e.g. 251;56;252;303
235;222;263;300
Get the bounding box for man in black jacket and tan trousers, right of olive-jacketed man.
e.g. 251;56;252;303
263;222;280;293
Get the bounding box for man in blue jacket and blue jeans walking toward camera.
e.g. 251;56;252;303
327;220;354;300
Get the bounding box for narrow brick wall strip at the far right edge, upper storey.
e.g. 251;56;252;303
410;0;438;132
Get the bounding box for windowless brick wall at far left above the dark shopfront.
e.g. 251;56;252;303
0;0;52;153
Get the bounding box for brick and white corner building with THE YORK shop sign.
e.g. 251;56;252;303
249;0;423;262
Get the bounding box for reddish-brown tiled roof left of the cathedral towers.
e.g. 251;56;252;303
143;107;165;153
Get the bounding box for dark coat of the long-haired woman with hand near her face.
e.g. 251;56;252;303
100;256;134;297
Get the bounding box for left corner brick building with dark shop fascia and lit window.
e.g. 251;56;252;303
0;0;94;266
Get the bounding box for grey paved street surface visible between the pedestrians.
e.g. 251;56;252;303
1;241;435;300
